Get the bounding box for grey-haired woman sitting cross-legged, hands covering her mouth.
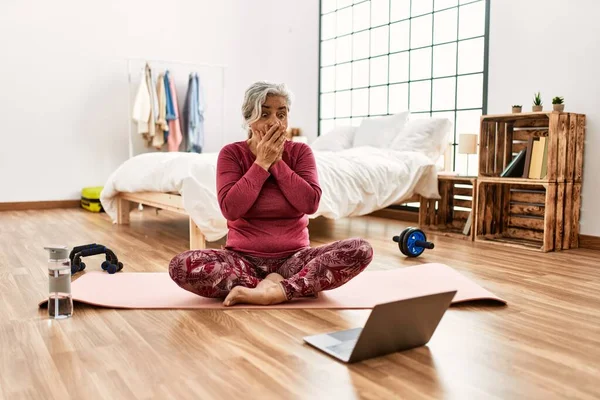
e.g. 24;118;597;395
169;82;373;306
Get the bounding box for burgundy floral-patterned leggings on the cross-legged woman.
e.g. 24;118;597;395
169;238;373;300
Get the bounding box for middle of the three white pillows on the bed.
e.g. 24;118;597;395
353;111;410;148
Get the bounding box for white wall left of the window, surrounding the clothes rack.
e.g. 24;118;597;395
0;0;319;202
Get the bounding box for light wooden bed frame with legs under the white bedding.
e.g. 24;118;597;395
117;192;206;250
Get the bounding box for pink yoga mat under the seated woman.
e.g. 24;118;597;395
39;264;506;309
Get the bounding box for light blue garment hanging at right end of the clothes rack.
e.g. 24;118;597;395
184;73;204;153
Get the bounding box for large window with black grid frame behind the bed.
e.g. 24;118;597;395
319;0;489;174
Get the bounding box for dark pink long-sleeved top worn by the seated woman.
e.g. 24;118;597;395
217;141;321;258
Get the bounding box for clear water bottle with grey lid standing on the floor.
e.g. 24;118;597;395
44;246;73;319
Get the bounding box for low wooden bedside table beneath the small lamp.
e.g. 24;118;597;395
419;175;477;240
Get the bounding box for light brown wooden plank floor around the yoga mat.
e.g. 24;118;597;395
0;209;600;400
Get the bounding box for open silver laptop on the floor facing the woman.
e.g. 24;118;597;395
303;290;456;363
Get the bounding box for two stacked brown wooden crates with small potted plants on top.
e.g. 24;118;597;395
474;112;586;252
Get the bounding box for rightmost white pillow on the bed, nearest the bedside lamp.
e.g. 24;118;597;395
390;118;452;161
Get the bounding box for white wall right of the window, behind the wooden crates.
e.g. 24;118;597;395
488;0;600;236
